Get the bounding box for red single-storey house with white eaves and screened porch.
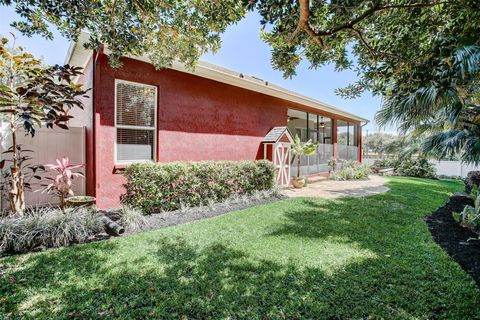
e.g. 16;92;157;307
66;34;366;208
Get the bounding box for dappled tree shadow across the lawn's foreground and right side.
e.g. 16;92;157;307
0;176;480;319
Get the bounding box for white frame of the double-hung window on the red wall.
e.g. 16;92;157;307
113;79;158;164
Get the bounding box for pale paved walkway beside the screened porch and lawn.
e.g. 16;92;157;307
283;175;389;199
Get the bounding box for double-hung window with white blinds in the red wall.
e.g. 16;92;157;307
115;80;157;162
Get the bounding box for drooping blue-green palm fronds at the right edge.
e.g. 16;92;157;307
375;45;480;164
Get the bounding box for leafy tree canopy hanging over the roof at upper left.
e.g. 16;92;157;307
0;0;246;68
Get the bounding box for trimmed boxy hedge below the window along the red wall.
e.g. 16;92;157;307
121;160;275;213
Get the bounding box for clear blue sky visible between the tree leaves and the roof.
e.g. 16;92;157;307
0;6;388;134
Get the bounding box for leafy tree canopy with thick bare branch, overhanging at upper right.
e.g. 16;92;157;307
251;0;480;97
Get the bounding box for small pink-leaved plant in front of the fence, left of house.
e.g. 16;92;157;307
43;157;84;209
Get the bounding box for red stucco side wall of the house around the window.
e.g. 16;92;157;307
94;55;360;208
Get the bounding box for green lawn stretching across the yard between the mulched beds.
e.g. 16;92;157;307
0;178;480;319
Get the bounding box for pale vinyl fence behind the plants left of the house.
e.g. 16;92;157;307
0;128;85;209
